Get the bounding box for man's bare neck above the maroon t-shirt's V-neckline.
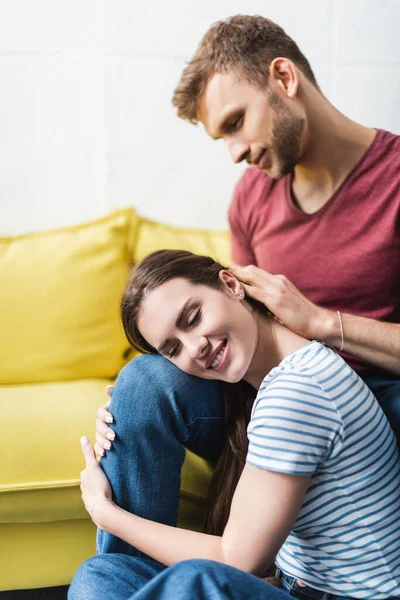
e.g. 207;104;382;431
292;96;376;214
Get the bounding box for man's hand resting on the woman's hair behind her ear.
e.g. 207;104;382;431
229;265;337;340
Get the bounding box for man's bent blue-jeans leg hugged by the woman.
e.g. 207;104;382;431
97;355;224;556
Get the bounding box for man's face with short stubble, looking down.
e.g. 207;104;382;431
198;73;305;179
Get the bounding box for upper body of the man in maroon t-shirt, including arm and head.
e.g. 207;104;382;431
173;15;400;437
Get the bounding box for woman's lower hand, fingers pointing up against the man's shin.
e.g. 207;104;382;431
81;437;112;524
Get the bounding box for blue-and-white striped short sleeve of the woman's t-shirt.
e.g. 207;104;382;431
246;375;343;475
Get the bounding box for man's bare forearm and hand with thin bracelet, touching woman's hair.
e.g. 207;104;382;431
231;265;400;375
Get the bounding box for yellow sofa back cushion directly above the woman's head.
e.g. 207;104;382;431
133;214;230;266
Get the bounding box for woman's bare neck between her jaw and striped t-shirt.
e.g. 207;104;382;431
244;317;310;389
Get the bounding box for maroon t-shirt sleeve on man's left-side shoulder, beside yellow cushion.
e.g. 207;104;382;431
229;175;256;266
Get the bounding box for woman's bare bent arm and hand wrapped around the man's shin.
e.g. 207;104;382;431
81;444;309;575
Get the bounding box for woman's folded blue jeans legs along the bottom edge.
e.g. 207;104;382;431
68;554;290;600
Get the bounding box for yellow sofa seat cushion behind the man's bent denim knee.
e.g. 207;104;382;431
0;379;212;523
